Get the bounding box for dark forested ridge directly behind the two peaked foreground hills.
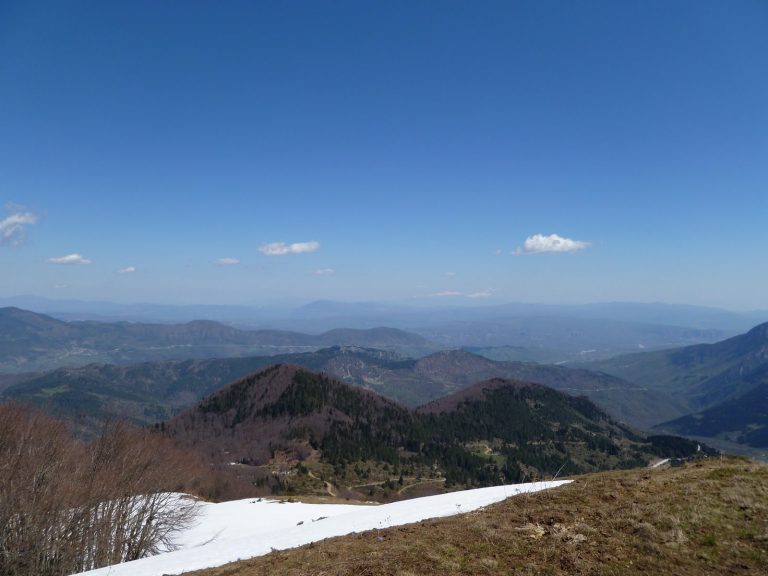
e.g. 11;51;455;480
0;346;685;427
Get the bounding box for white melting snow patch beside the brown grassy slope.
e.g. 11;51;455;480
73;480;569;576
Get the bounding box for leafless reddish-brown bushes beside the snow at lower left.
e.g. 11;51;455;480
0;404;200;576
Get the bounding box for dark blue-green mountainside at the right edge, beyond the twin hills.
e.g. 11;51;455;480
587;323;768;448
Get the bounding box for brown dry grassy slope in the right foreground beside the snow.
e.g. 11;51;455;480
194;459;768;576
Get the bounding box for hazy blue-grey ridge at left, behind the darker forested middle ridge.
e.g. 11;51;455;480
0;308;438;372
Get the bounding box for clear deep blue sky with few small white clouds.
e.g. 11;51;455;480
0;0;768;308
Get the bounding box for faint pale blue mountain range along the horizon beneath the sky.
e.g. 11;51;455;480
0;296;768;334
